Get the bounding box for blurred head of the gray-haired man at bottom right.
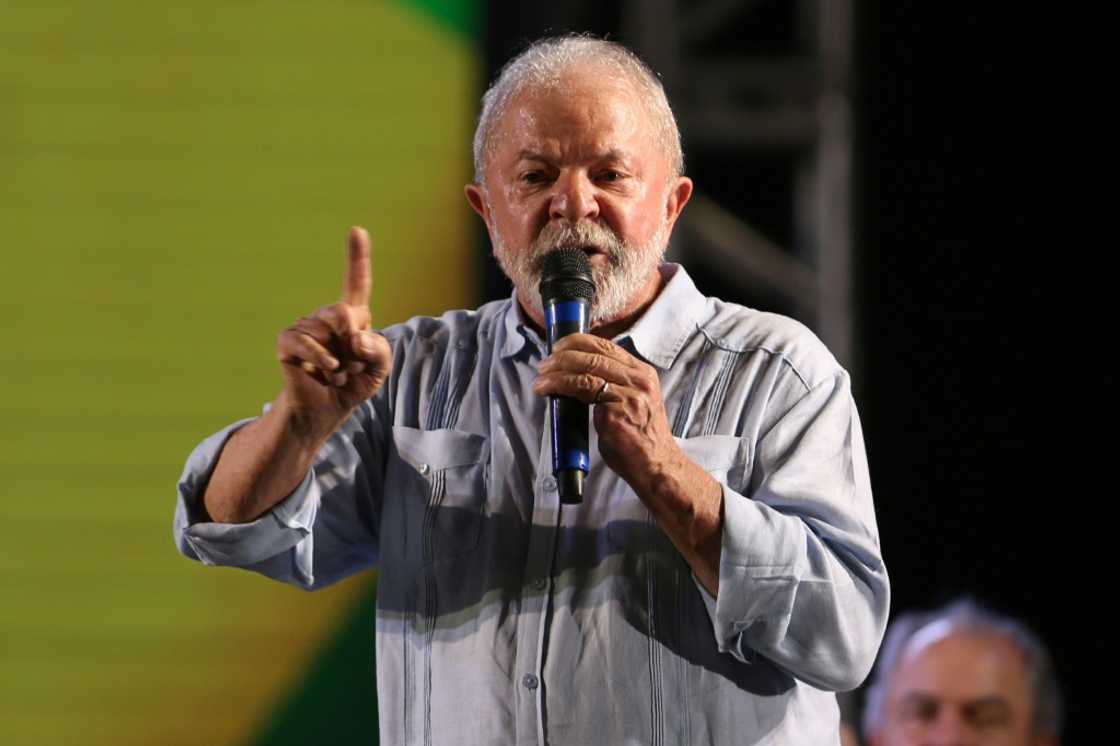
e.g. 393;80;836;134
864;600;1062;746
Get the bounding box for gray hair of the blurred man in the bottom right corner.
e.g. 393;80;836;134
862;598;1064;736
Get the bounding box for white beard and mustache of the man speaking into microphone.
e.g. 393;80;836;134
491;221;665;326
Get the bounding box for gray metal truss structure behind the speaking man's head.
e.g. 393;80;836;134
619;0;856;369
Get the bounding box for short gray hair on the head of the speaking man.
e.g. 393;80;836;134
474;34;684;184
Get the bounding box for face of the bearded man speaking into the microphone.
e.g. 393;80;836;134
467;69;692;324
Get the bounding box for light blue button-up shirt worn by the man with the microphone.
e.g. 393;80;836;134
175;265;889;746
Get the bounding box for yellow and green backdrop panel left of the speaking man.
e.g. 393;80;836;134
0;0;478;746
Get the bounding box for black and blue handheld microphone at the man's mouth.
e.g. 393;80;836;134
540;249;595;505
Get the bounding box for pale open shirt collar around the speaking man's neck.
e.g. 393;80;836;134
501;263;708;370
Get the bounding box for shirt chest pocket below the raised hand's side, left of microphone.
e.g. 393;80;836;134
393;426;489;562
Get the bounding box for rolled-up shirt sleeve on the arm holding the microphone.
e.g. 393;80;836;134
697;372;889;690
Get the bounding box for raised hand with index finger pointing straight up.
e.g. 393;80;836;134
277;227;392;437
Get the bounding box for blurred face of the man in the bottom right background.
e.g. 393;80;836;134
870;632;1051;746
